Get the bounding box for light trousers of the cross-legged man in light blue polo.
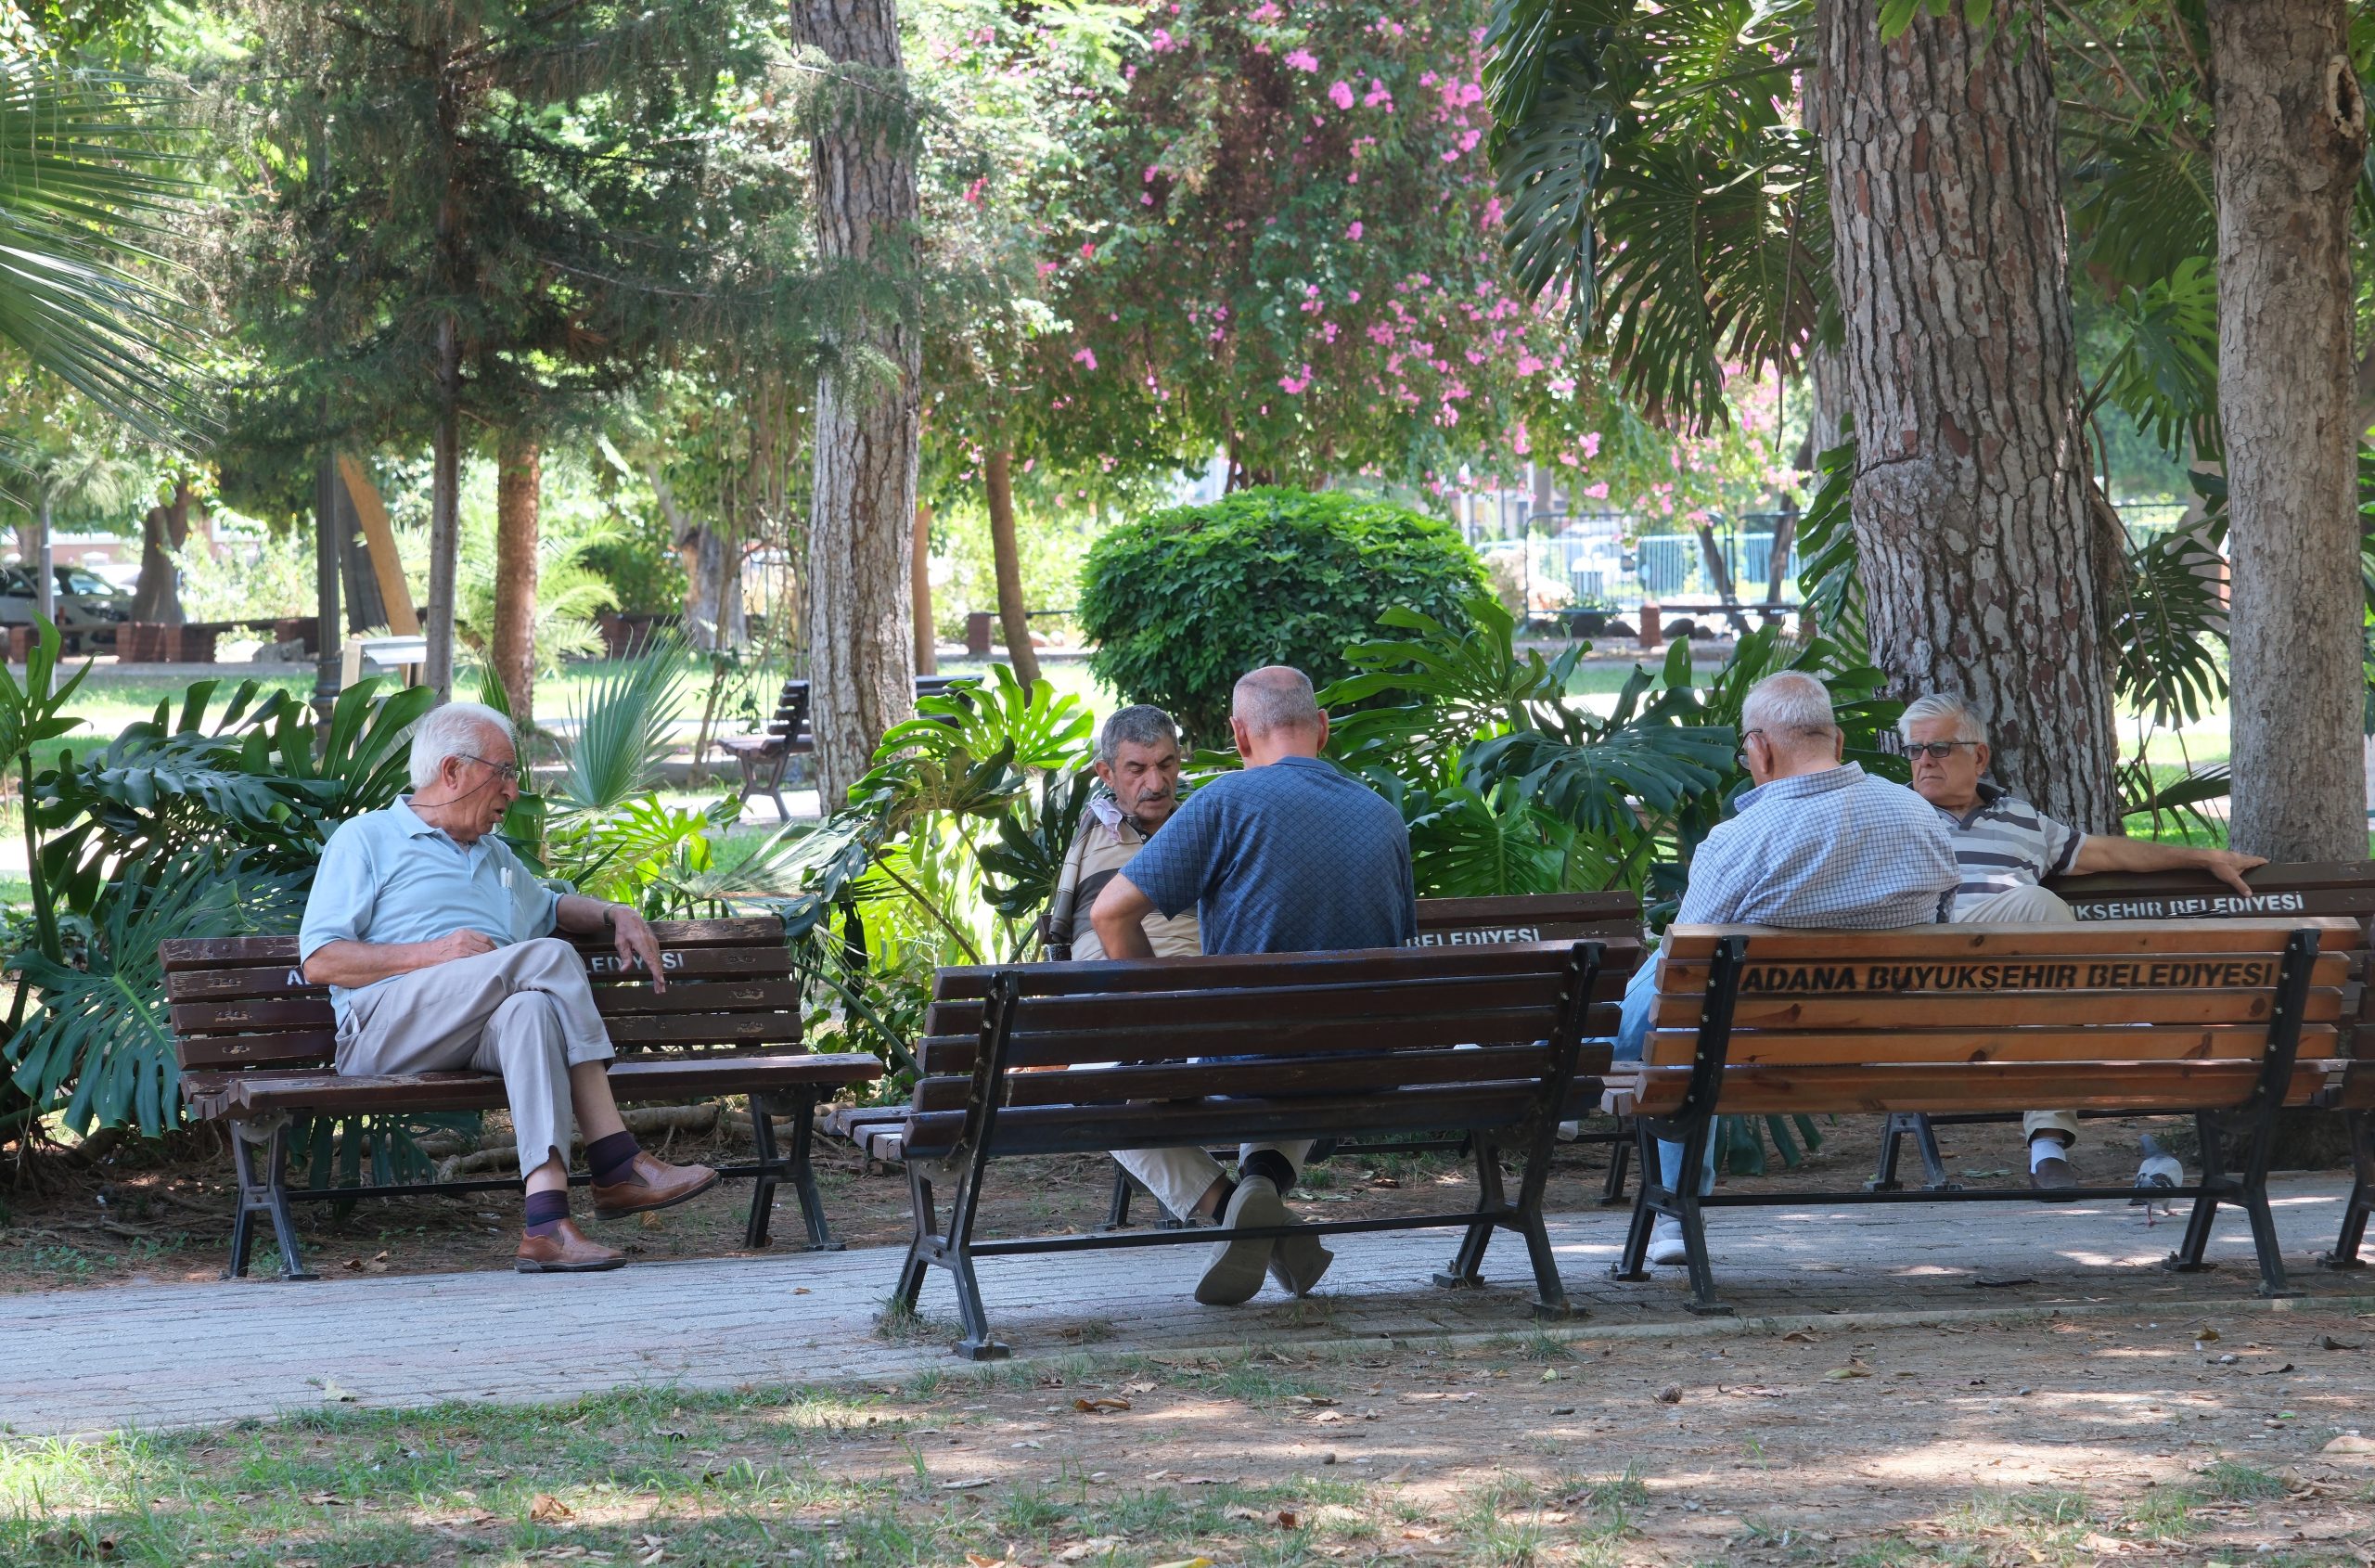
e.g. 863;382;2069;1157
338;936;612;1176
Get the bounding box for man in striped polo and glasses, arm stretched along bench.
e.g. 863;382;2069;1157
1897;694;2268;1190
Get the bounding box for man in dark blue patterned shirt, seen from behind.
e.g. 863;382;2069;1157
1087;665;1418;1306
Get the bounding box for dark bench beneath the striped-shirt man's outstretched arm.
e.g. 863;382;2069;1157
1871;860;2375;1268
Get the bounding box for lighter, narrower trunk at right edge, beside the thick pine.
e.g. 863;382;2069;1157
2209;0;2368;860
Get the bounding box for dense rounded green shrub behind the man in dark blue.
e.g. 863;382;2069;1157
1081;489;1487;746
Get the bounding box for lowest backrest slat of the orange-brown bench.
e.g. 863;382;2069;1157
1608;1062;2340;1116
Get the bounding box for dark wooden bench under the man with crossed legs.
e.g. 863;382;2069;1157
160;915;881;1280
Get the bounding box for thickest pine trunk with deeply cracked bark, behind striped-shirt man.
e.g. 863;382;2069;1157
1819;0;2119;831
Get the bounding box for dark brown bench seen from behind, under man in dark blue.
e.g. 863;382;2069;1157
895;941;1637;1359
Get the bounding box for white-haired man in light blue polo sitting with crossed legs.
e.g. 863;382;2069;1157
297;703;717;1273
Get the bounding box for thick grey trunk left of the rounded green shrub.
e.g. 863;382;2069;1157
790;0;924;813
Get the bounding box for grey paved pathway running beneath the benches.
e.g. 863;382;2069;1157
14;1176;2375;1435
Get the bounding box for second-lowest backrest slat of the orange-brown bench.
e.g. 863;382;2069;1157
1646;1024;2337;1073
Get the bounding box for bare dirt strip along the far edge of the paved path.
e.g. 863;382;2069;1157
0;1116;2279;1290
